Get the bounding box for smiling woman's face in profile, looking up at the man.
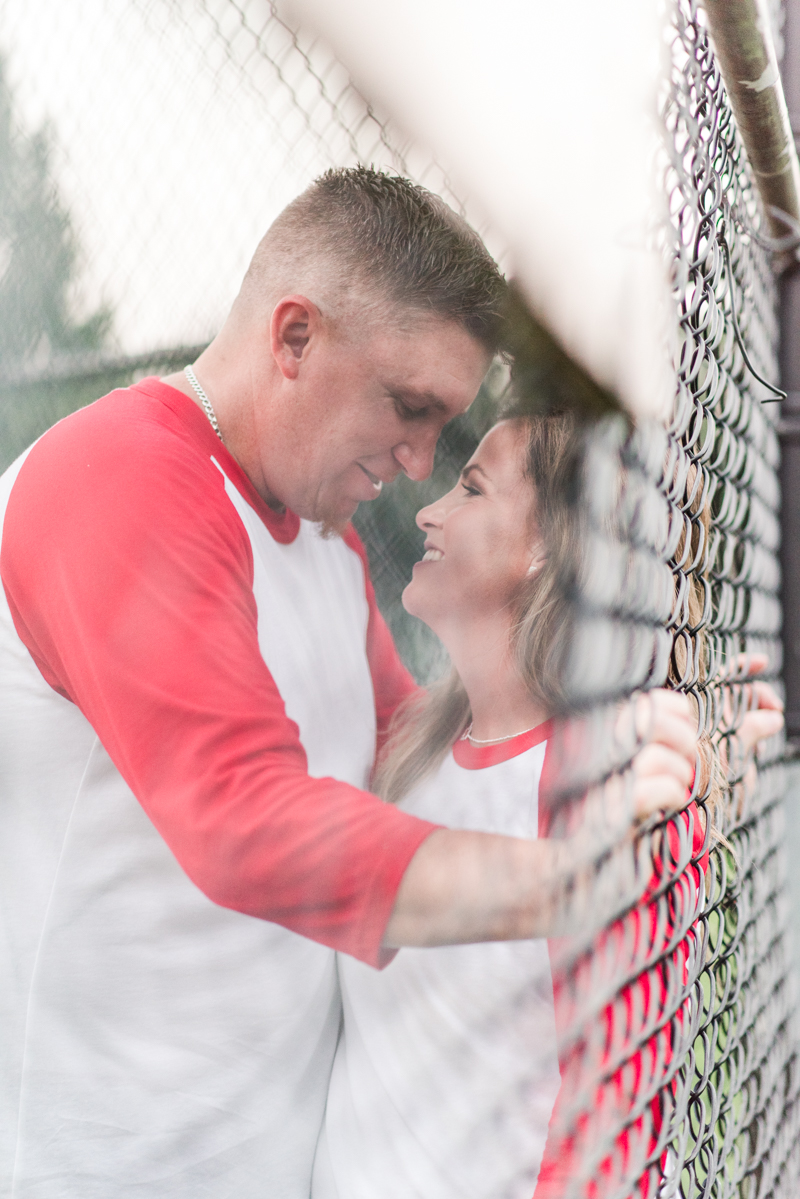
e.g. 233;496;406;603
403;421;543;635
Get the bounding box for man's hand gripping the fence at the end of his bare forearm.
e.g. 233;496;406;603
633;689;697;820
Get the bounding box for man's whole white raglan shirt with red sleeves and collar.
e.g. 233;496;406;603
0;379;435;1199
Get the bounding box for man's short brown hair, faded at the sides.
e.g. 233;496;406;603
236;167;506;353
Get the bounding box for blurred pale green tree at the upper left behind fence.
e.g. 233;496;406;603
0;58;112;374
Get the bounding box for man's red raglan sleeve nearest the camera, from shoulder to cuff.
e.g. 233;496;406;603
0;391;435;964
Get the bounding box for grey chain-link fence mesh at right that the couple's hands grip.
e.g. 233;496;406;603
542;0;799;1197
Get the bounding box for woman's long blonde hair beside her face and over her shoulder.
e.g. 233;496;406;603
373;408;578;803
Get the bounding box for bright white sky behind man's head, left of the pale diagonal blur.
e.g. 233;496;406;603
0;0;412;353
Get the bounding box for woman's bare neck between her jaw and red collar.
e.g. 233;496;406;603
440;616;549;741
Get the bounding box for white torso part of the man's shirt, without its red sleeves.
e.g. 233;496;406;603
0;386;383;1199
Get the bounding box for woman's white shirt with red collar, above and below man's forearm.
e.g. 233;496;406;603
312;724;560;1199
